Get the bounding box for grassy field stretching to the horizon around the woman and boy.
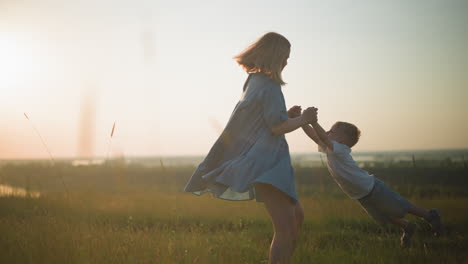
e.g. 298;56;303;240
0;163;468;263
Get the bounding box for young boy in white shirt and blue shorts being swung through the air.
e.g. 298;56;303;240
296;107;443;247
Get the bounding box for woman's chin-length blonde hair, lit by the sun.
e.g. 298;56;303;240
234;32;291;85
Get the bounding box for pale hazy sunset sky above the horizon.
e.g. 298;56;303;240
0;0;468;159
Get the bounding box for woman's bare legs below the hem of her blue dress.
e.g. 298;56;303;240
255;183;299;264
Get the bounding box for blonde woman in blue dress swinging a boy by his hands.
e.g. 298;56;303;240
185;32;317;264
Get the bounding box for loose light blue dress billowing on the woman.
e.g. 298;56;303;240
185;73;297;202
